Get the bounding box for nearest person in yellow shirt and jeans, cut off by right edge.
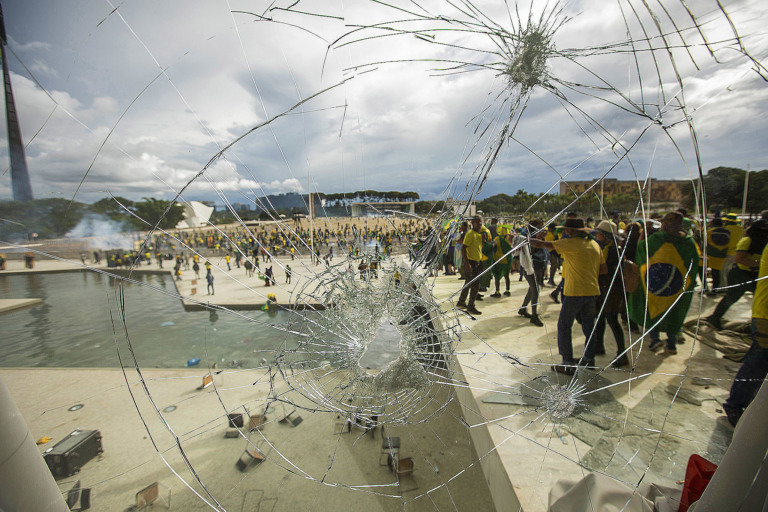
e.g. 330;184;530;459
723;242;768;426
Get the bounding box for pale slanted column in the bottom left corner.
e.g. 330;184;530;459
0;378;69;512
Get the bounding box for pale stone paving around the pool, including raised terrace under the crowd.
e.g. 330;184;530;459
0;258;749;511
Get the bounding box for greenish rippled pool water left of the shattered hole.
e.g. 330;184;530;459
0;271;298;368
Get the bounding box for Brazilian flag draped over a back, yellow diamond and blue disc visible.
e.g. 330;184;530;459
629;232;699;333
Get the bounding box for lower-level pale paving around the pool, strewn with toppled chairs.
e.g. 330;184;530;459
0;260;493;512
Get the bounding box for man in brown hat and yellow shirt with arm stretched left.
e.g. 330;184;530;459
531;217;607;375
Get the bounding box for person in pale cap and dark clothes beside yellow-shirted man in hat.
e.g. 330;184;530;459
594;220;629;368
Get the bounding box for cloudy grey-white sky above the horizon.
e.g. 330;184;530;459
0;0;768;203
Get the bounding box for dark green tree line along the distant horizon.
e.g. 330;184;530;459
0;167;768;241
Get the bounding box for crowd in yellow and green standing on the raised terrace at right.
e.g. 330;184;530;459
436;210;768;412
